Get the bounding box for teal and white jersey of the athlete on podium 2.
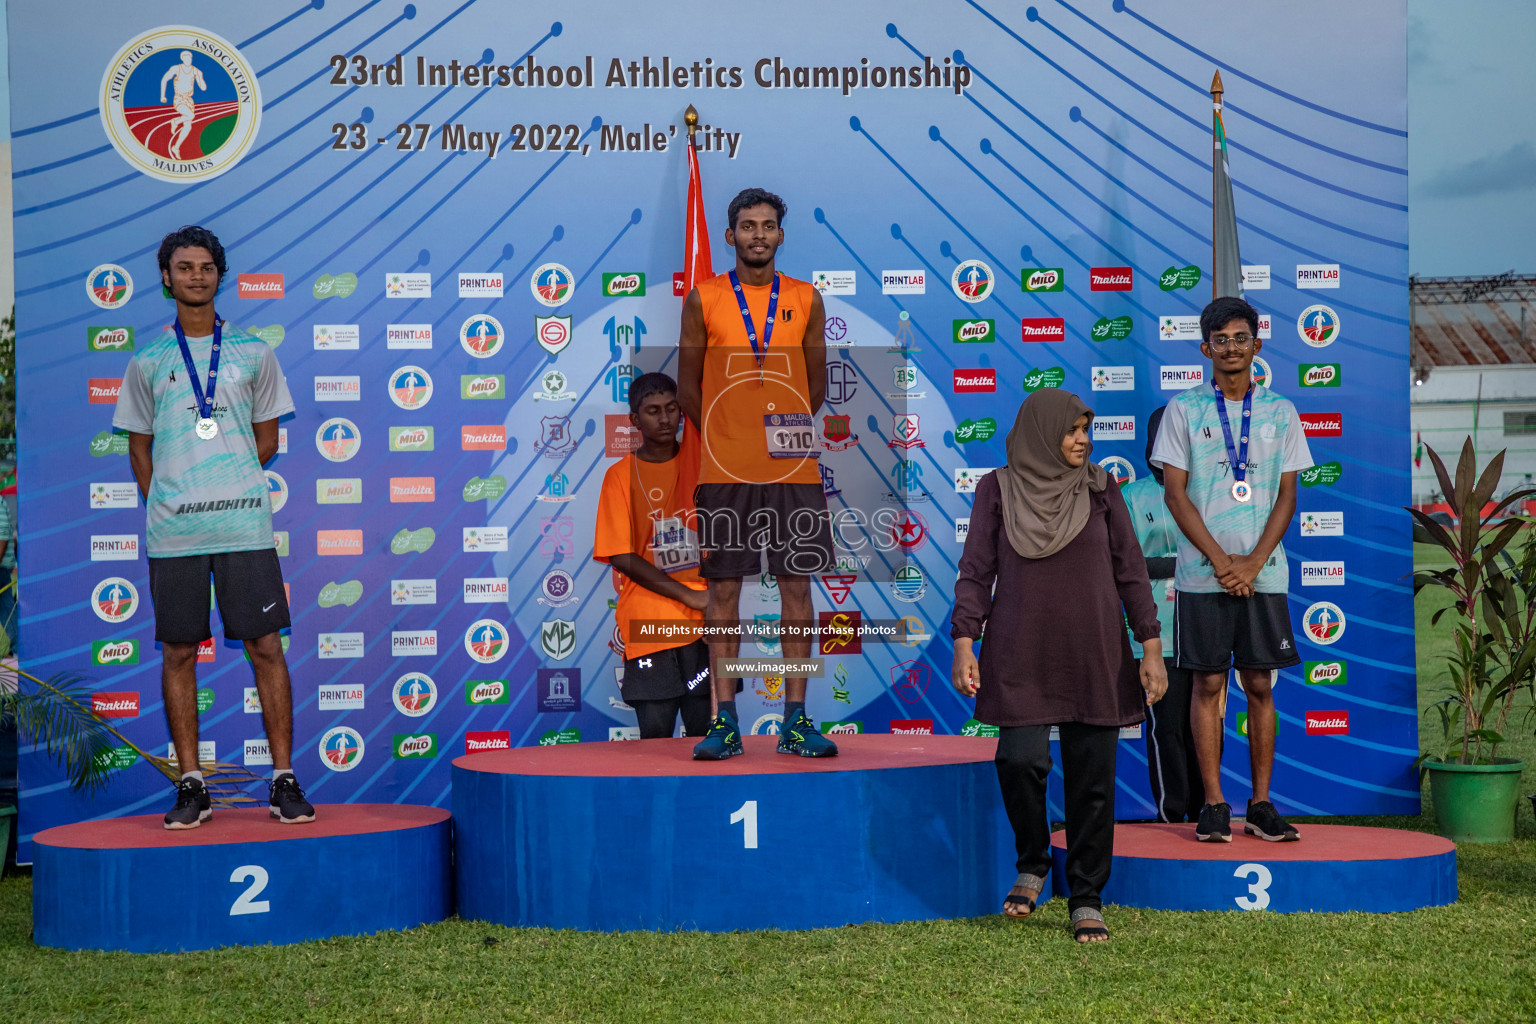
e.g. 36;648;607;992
112;322;293;559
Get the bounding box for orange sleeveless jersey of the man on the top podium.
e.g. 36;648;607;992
699;273;822;484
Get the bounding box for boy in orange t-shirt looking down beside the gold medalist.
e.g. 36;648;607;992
593;373;710;740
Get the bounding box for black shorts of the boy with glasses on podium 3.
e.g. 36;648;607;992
1174;591;1301;672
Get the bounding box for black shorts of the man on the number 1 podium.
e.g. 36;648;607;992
693;484;836;579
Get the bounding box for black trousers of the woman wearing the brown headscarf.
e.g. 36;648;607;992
995;722;1120;910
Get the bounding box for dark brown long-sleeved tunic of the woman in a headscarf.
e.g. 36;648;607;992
949;473;1160;726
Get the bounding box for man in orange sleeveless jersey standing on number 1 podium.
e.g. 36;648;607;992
677;189;837;760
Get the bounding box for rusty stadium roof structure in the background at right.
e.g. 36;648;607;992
1409;270;1536;370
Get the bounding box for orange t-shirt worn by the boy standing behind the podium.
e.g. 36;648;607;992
591;421;707;659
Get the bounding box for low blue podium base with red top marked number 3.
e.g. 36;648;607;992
1051;820;1456;913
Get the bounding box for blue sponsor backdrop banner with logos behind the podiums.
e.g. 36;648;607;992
9;0;1418;859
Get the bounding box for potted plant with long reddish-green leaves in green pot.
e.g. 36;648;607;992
1409;438;1536;843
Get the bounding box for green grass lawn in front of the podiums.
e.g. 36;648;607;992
0;543;1536;1024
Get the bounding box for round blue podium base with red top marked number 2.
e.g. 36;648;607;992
32;804;453;953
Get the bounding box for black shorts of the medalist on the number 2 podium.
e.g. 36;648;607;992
149;548;292;643
